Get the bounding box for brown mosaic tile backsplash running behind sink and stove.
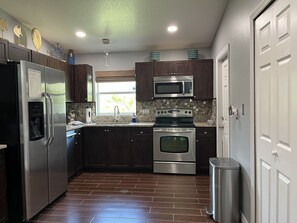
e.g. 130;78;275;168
66;99;216;123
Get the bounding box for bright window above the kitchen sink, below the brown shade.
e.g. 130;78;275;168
96;81;136;115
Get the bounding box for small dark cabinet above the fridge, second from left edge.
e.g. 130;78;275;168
8;43;31;62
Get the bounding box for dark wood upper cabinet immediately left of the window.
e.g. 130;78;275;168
73;64;93;102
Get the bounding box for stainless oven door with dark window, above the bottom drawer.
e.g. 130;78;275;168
153;128;196;162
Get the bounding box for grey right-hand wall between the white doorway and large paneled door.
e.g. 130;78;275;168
212;0;263;222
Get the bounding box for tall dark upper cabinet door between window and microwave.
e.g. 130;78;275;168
135;62;154;101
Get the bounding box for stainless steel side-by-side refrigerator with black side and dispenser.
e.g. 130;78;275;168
0;61;67;222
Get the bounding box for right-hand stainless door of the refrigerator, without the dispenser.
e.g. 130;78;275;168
45;68;67;202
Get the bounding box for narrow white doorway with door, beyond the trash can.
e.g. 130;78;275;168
216;44;230;157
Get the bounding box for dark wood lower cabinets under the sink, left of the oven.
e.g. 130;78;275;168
83;127;153;169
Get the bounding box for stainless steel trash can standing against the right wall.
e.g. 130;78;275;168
208;158;240;223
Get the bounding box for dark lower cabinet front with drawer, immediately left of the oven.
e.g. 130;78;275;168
131;127;153;169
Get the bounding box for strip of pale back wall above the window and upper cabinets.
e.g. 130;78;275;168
75;48;211;71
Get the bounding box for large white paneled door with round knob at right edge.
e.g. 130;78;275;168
255;0;297;223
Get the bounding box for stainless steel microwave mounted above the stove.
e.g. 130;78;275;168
154;76;193;98
